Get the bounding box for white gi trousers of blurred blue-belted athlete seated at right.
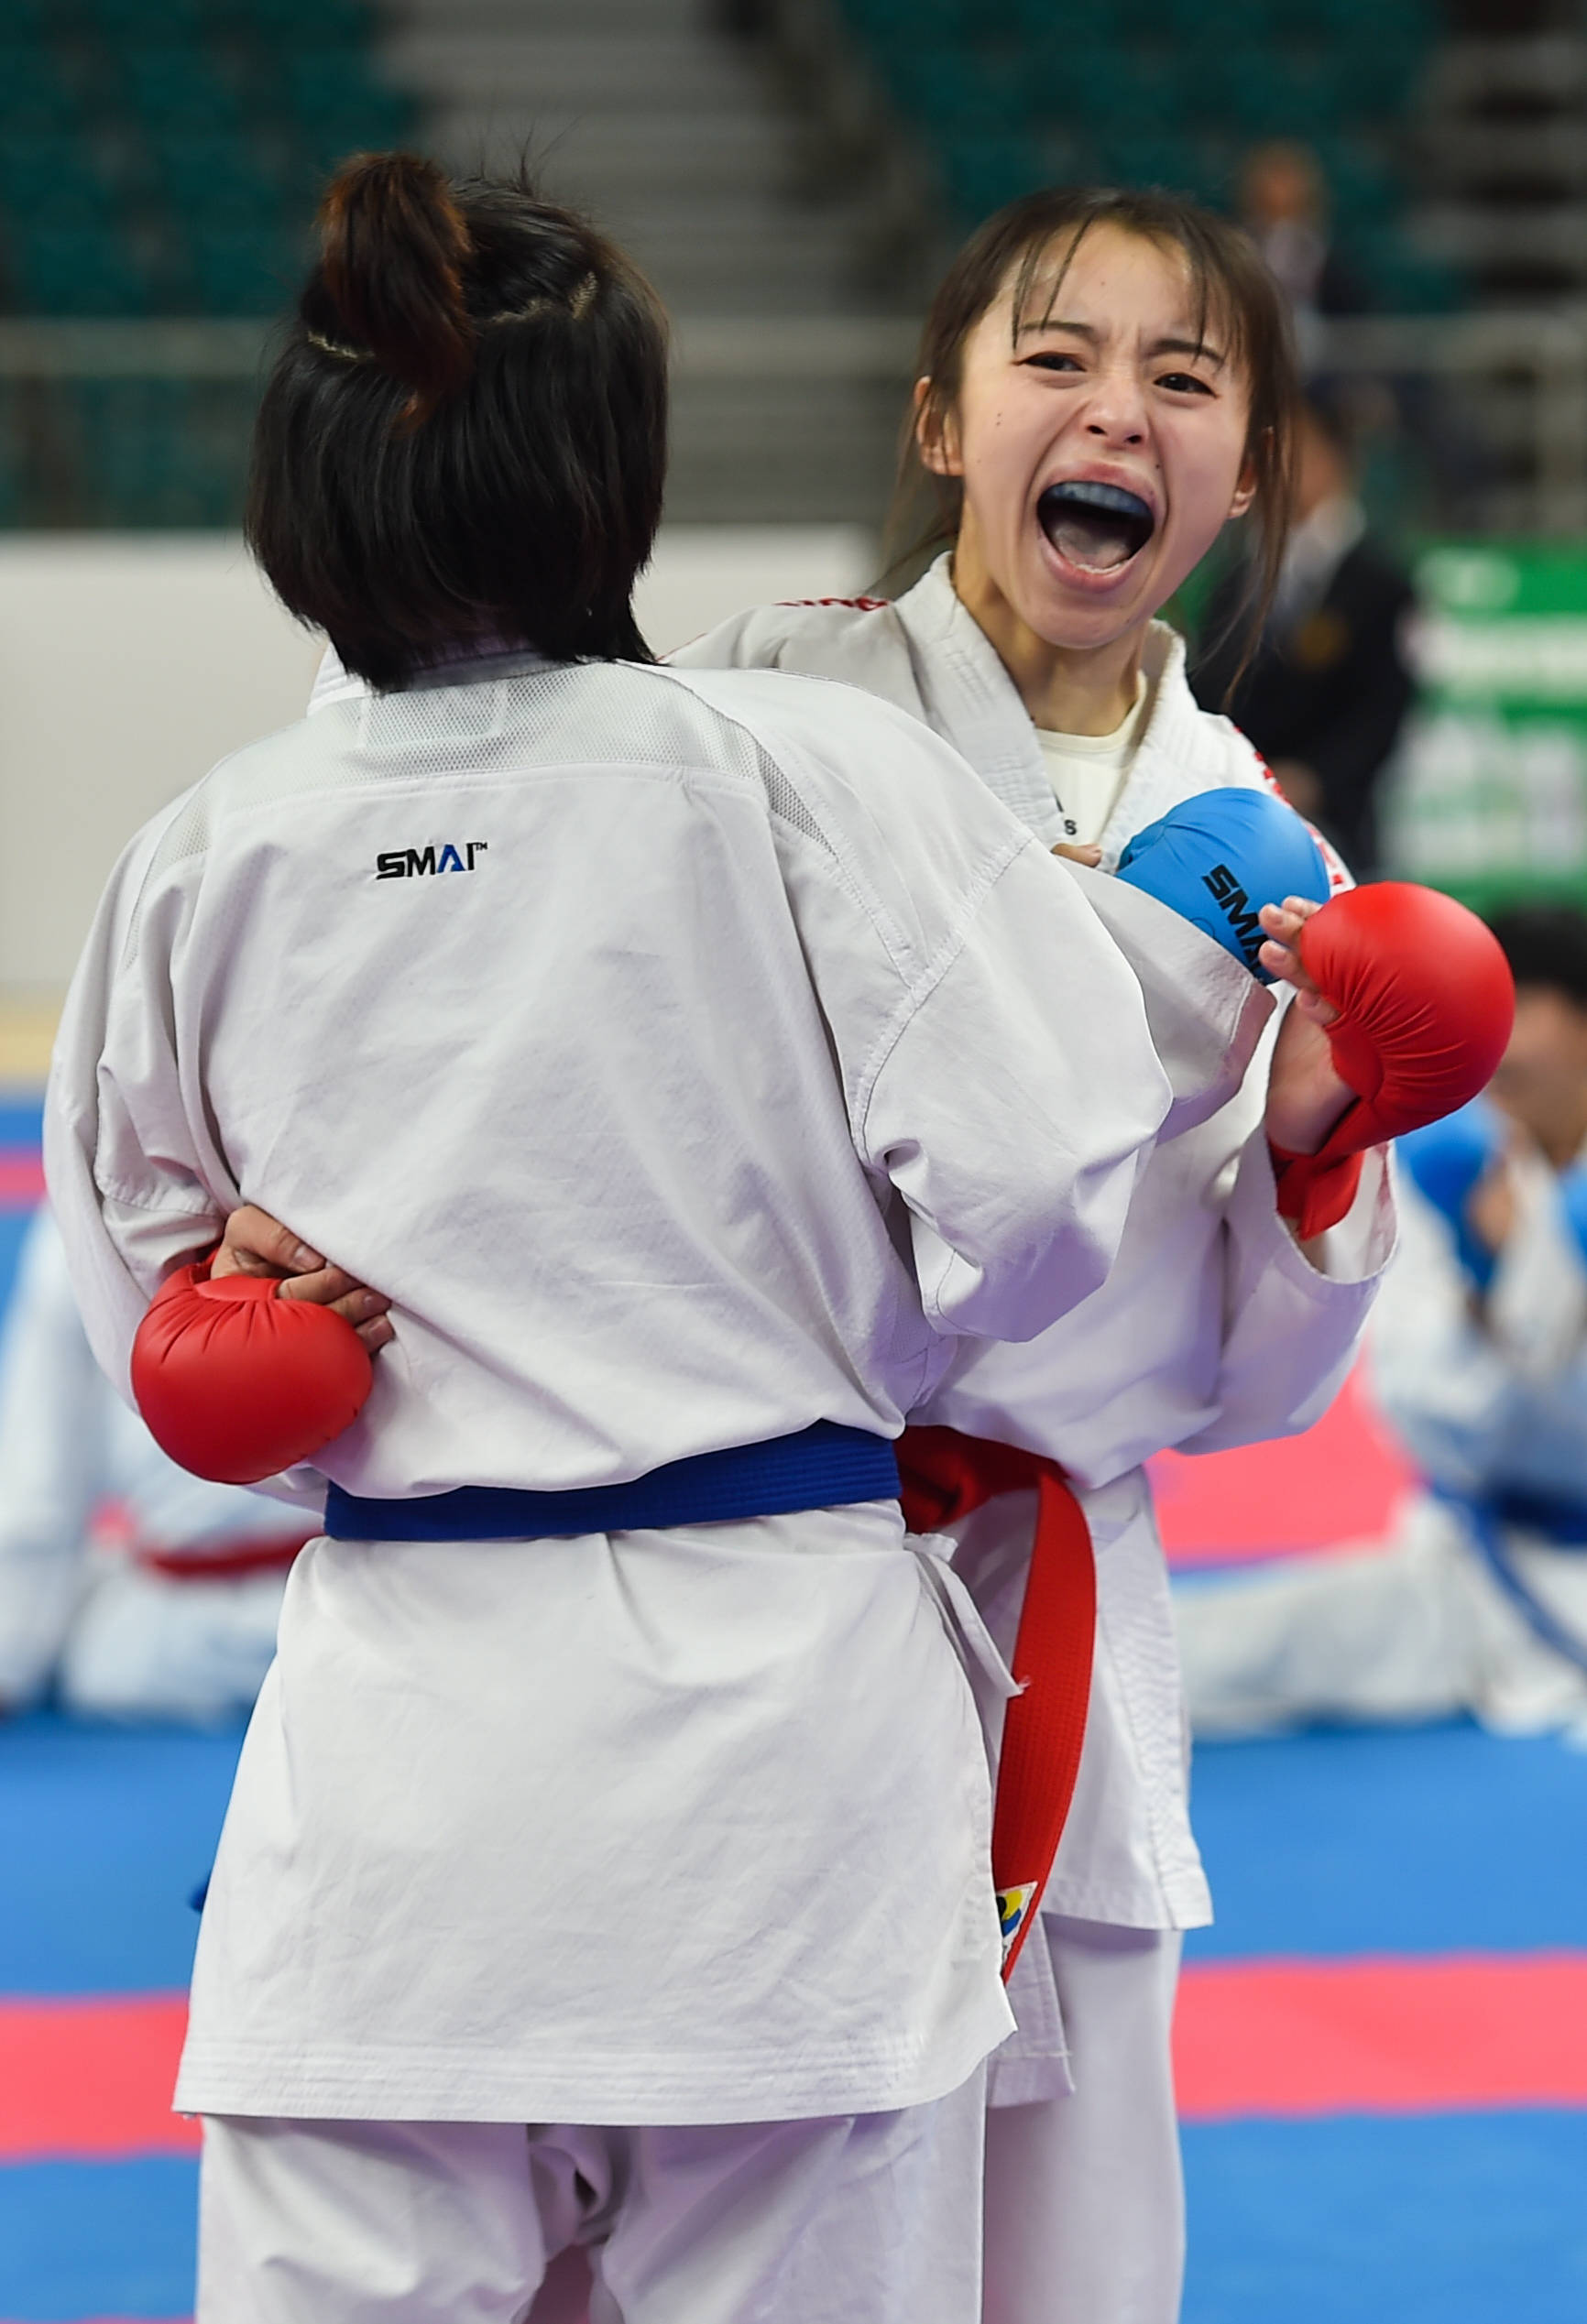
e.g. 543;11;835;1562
1174;1499;1587;1736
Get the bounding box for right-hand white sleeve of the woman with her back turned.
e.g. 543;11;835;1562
853;836;1171;1341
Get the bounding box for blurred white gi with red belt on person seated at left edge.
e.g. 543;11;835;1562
0;1206;309;1722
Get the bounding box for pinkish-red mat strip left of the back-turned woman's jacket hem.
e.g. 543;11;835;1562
0;1994;198;2164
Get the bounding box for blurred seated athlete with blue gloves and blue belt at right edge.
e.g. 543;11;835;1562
1176;904;1587;1736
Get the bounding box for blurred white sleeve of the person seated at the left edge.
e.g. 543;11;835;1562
0;1211;114;1708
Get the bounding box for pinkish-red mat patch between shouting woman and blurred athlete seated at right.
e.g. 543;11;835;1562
1148;1367;1415;1566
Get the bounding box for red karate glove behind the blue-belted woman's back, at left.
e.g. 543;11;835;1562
133;1260;374;1485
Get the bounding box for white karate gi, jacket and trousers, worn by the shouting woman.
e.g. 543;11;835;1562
673;558;1395;2324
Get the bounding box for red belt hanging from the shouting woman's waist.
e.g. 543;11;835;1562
897;1429;1097;1978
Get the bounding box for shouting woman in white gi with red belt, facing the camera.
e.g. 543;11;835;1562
204;193;1395;2324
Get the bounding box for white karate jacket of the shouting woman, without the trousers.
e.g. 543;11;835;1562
673;558;1395;1942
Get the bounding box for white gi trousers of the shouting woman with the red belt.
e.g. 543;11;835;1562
985;1913;1185;2324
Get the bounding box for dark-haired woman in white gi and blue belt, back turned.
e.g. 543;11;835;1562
47;156;1226;2324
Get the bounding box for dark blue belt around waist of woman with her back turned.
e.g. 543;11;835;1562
325;1420;899;1541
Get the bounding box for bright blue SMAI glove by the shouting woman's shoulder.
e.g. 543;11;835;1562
1118;786;1331;986
